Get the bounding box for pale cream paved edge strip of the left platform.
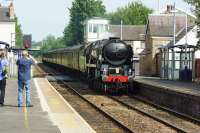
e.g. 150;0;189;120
34;78;95;133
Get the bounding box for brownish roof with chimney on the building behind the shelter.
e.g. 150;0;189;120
146;5;196;37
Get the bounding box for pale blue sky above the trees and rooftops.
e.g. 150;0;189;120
0;0;193;41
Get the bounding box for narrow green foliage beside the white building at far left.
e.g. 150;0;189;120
15;17;23;48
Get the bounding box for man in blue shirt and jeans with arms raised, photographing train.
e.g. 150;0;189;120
17;50;34;107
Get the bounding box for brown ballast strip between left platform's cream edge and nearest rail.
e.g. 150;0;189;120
37;65;134;133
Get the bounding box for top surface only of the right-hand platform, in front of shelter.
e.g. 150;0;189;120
135;77;200;97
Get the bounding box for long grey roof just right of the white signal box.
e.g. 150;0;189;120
109;25;146;41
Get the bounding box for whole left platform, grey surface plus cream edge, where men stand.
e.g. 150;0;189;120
0;78;95;133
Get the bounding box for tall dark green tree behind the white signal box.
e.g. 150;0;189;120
63;0;106;45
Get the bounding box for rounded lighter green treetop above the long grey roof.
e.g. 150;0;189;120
107;2;153;25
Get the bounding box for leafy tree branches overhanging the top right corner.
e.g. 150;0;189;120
185;0;200;49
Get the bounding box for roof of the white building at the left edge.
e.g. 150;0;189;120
0;7;15;22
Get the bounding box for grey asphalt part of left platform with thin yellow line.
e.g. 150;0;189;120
0;80;60;133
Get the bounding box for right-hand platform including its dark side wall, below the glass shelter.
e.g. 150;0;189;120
133;77;200;122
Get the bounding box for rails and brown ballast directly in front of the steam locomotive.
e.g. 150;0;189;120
36;63;199;132
